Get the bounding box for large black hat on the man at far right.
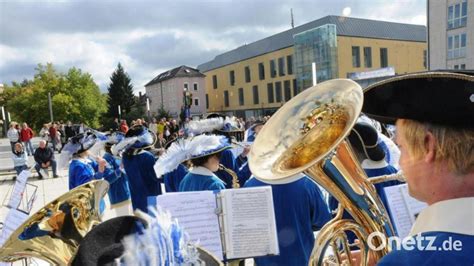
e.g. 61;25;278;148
362;70;474;128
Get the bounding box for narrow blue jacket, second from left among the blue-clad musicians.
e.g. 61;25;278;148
104;152;130;204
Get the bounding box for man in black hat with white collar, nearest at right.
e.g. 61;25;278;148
363;72;474;265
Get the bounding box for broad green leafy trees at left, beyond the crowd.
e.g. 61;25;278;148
1;63;106;129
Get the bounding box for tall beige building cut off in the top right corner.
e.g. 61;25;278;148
427;0;474;70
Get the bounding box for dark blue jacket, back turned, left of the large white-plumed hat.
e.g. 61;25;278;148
122;151;161;212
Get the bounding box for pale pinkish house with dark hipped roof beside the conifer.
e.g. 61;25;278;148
145;66;206;117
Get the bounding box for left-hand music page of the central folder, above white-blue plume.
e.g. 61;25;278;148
156;191;223;260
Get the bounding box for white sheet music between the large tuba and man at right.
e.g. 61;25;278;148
384;184;427;238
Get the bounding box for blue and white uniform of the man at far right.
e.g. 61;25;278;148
378;197;474;265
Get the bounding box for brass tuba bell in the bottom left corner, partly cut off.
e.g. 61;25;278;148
0;180;109;265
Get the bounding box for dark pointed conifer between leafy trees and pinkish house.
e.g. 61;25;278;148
107;63;135;118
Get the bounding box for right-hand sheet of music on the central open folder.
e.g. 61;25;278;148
221;186;279;259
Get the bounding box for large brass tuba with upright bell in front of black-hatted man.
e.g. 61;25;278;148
249;79;394;265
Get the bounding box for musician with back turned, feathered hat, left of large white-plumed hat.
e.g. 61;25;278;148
122;125;162;212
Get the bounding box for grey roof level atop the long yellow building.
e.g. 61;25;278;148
197;16;426;73
